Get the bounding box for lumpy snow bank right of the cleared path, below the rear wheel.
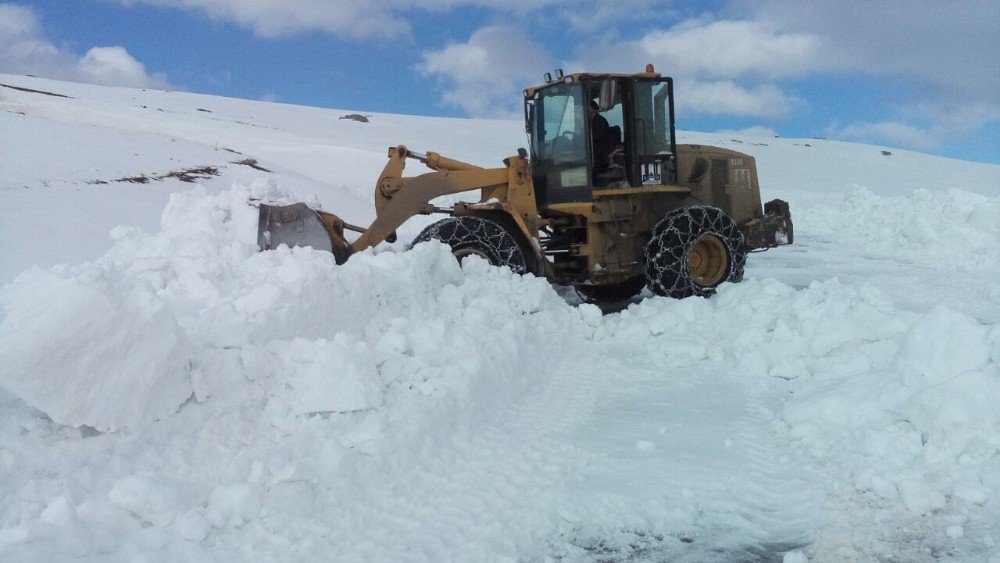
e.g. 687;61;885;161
594;279;1000;557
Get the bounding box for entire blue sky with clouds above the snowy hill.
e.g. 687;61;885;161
0;0;1000;163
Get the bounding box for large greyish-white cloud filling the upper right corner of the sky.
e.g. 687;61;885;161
734;0;1000;150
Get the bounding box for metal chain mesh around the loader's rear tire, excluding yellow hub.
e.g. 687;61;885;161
646;205;747;298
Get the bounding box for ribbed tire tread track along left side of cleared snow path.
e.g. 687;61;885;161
290;348;599;561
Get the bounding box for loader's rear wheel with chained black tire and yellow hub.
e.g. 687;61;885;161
646;205;747;299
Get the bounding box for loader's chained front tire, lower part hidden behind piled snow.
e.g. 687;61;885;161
413;215;535;274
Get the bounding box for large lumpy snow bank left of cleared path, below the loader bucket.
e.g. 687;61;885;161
0;185;596;558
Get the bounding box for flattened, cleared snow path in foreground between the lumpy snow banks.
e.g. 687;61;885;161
240;334;818;561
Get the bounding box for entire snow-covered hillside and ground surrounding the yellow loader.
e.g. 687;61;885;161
0;74;1000;561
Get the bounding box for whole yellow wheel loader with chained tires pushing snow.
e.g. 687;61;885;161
258;65;793;301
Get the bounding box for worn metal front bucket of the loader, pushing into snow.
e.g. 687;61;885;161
257;203;351;264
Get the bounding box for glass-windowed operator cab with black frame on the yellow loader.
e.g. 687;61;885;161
524;66;676;206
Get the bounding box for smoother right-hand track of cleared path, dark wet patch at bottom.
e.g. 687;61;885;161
552;366;821;561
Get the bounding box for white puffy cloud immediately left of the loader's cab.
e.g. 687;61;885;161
417;26;552;117
